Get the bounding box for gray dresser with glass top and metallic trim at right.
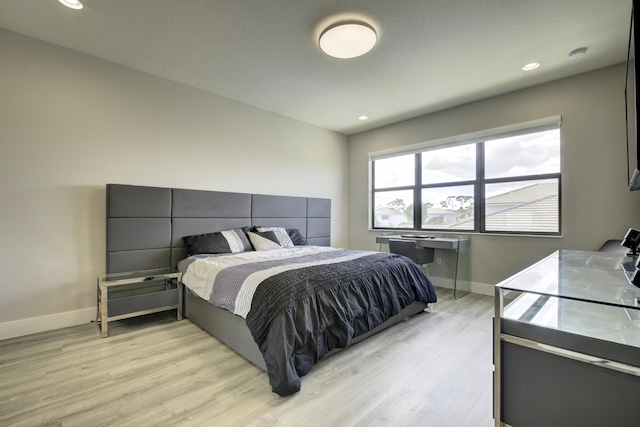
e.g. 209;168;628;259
494;250;640;427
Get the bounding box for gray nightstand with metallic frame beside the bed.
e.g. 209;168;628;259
97;268;182;337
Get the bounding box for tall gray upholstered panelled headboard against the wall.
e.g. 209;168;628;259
107;184;331;273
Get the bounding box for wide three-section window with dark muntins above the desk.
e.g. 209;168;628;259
369;119;561;235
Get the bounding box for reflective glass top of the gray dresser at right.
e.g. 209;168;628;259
497;250;640;310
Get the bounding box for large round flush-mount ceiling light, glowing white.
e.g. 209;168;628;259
320;21;377;59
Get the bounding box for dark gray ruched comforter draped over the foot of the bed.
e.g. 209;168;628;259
247;253;436;396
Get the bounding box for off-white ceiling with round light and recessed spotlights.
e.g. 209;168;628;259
0;0;631;135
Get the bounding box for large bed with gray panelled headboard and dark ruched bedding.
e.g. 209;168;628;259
107;184;436;396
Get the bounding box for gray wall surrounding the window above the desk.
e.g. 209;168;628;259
348;65;640;285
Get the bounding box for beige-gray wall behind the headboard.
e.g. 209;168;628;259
0;29;347;339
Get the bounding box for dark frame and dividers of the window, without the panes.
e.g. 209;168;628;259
368;116;562;237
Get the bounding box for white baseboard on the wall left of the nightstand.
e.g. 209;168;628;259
0;307;96;340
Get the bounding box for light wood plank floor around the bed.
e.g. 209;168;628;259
0;289;493;427
